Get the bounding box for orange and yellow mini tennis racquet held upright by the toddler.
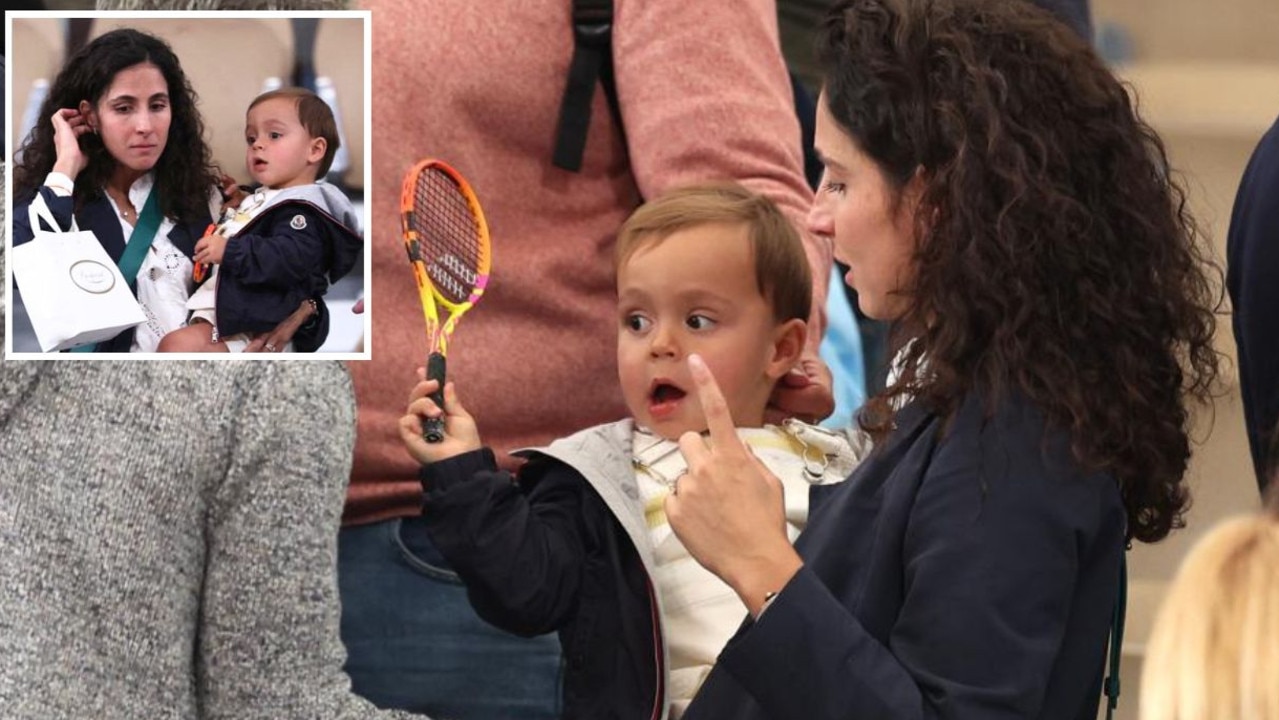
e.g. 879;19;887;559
400;159;490;442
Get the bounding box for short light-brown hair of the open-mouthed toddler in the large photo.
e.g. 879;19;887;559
613;182;812;322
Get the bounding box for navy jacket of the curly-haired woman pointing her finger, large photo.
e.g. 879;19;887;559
684;399;1126;720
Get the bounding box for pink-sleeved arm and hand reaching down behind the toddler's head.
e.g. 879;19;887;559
613;0;834;421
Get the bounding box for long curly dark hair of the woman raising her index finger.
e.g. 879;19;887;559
819;0;1221;542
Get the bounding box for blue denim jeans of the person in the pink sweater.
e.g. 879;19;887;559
338;518;560;720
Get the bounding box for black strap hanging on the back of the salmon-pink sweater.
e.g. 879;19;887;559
551;0;622;173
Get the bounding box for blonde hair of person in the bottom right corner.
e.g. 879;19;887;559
1141;512;1279;720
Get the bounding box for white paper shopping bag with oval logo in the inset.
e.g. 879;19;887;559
9;194;146;353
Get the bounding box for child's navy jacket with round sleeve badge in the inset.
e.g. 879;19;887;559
216;198;363;352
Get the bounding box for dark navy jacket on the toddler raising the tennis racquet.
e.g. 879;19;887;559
421;448;663;720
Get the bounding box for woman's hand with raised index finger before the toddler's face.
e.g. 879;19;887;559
665;354;803;615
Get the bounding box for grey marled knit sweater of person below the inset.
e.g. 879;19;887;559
0;166;420;720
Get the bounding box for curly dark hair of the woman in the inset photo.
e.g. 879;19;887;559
13;28;217;221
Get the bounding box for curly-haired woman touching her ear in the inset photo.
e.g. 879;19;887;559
13;28;319;352
